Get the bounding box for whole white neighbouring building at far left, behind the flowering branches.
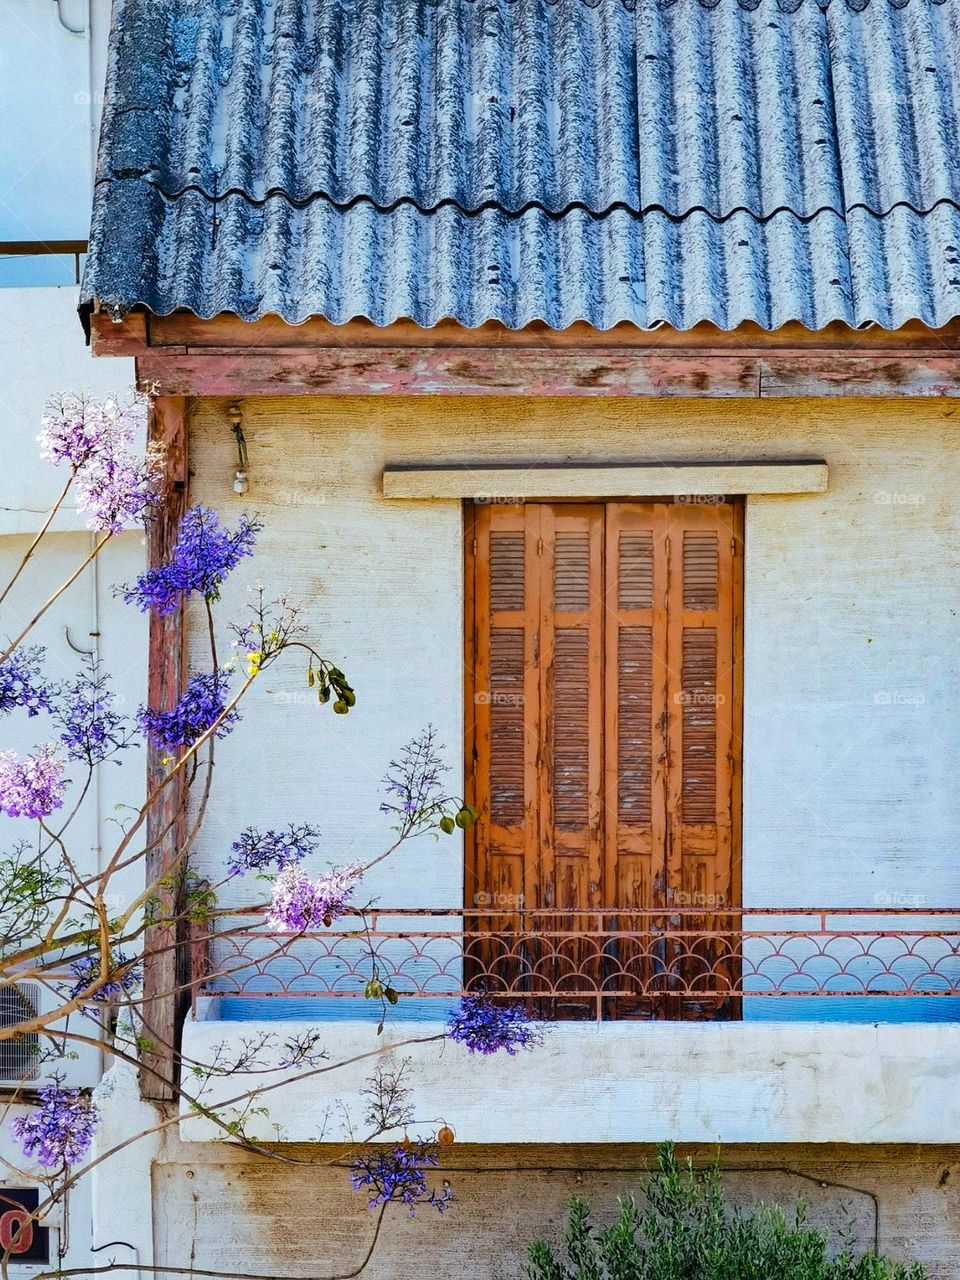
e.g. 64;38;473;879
0;0;146;1280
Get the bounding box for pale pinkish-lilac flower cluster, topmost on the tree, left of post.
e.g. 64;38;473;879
38;396;159;534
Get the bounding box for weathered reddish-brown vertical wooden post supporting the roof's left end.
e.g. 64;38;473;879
140;396;187;1102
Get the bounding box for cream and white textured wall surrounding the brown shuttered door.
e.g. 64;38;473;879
191;398;960;906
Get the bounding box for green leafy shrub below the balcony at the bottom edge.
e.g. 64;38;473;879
525;1143;925;1280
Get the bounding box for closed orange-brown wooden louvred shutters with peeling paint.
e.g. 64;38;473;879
465;503;741;1018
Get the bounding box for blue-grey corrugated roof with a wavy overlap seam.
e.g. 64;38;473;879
84;0;960;329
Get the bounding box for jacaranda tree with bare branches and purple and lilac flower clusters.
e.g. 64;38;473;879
0;396;540;1275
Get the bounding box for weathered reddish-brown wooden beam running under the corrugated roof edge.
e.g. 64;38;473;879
91;312;960;399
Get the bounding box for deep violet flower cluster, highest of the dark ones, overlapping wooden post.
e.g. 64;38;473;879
123;506;262;613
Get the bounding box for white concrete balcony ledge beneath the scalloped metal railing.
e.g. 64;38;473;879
179;1007;960;1144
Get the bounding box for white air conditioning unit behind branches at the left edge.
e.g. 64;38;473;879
0;982;101;1089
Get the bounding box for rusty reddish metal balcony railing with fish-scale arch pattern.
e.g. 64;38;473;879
195;908;960;1020
